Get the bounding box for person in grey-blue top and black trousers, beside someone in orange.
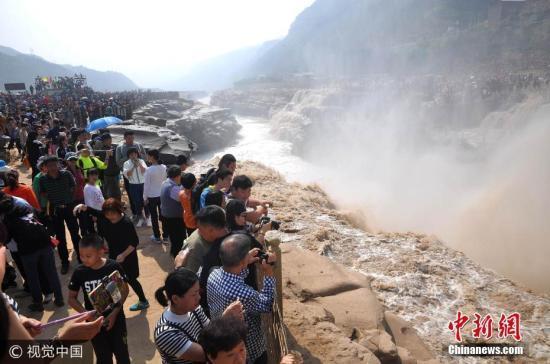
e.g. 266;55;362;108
160;166;187;257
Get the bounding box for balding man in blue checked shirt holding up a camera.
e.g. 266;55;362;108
207;234;276;364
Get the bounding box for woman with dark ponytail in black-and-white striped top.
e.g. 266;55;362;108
154;268;242;364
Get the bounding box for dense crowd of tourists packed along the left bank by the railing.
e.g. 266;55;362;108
0;86;298;363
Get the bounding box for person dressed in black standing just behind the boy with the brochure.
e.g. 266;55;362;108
97;198;149;311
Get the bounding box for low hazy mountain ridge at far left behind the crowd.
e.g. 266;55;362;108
0;46;139;91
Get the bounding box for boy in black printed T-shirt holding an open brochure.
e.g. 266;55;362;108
69;235;130;364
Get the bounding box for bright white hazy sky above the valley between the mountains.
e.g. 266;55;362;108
0;0;314;87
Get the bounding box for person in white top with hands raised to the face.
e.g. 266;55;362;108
122;147;147;226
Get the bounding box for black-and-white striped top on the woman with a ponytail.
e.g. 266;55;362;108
154;306;209;364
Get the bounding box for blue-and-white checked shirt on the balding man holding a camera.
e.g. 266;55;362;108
206;268;275;363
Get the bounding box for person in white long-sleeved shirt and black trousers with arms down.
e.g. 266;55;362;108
143;149;168;243
